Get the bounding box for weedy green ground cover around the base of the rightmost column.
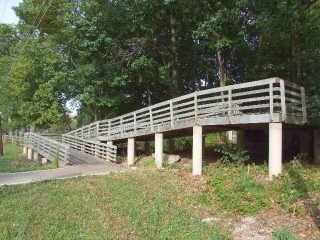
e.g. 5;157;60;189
200;154;320;215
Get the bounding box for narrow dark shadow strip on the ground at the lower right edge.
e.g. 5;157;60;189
289;166;320;231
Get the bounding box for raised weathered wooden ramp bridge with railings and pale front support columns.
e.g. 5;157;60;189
23;78;307;179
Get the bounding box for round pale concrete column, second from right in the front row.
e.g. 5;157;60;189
192;126;203;176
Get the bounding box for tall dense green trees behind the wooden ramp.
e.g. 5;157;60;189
0;0;320;131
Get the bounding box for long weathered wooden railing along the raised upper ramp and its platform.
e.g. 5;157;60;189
68;78;307;140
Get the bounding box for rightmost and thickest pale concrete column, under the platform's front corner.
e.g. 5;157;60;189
269;123;282;180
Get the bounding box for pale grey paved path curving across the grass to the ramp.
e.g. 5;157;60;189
0;162;127;186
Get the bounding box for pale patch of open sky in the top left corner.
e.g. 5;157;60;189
0;0;22;24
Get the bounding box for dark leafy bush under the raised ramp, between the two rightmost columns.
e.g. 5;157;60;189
213;143;250;165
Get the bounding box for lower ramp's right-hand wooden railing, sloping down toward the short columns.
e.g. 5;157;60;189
62;134;117;162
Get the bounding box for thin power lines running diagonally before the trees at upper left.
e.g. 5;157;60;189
6;0;53;78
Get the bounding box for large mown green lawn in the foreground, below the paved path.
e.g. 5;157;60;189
0;171;230;240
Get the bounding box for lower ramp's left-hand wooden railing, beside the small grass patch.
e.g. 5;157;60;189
24;132;70;163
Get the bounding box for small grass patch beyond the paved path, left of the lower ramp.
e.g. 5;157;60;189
0;143;50;173
